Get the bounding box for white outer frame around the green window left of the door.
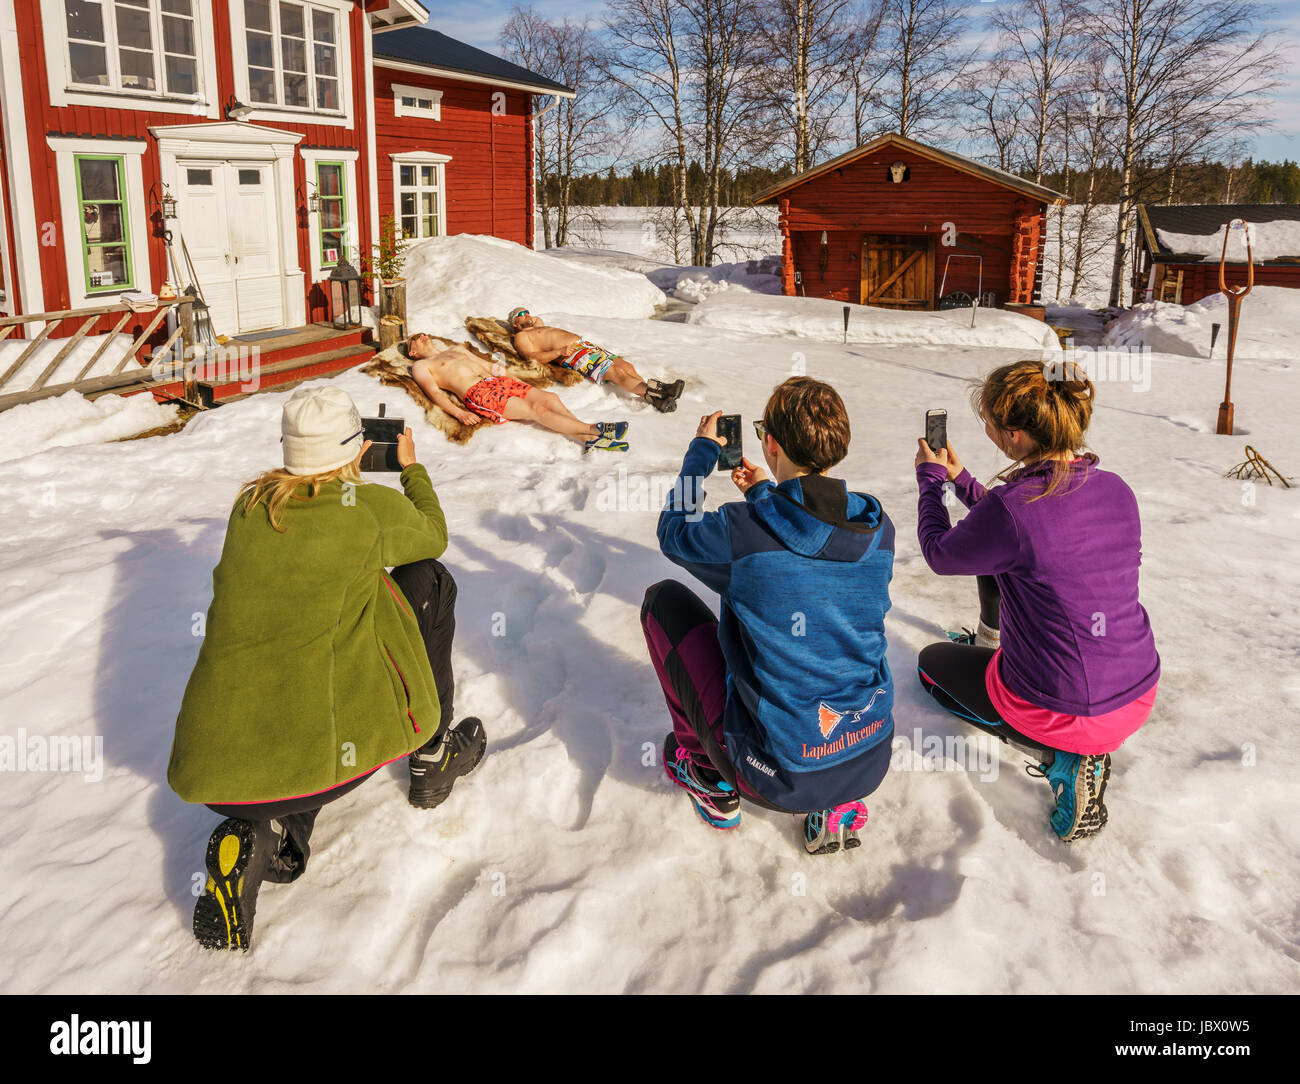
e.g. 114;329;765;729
46;135;153;308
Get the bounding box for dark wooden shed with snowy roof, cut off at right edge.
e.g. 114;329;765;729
1134;203;1300;305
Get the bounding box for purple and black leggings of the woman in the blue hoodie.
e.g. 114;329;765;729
641;580;787;812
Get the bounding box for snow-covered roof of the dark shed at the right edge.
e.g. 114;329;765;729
1138;203;1300;264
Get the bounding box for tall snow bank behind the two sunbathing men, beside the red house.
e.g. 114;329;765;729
406;234;667;338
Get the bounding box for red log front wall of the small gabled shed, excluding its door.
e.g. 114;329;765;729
781;147;1043;304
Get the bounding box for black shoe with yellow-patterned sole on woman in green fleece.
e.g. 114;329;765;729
194;818;274;951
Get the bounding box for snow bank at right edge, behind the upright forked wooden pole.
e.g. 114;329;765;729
1105;286;1300;360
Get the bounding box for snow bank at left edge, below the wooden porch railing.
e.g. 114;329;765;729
0;391;178;463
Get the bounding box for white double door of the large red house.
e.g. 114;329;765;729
177;160;285;335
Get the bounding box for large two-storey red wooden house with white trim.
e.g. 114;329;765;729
0;0;573;371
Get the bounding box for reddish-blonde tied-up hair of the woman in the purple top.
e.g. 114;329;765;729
971;359;1097;500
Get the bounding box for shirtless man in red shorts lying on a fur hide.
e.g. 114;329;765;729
407;334;628;451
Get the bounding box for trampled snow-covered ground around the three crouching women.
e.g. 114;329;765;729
0;233;1300;993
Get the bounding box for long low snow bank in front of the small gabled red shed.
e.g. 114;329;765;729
686;291;1060;351
